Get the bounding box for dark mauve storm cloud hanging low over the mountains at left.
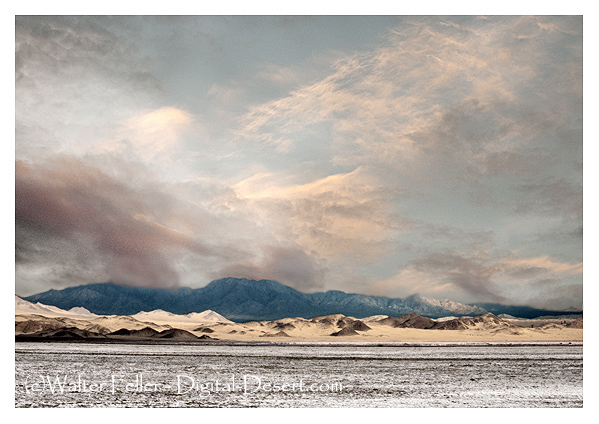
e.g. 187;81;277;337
15;157;216;287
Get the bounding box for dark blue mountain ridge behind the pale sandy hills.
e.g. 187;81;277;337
24;278;580;322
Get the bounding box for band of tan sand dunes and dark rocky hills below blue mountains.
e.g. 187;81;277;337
15;314;583;342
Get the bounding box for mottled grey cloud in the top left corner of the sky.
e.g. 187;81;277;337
15;16;160;93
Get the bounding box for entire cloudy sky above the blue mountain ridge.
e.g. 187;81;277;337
14;16;583;309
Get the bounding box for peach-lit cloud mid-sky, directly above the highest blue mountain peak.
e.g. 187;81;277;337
236;168;392;262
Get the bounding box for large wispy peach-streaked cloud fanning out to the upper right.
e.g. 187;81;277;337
238;17;582;178
